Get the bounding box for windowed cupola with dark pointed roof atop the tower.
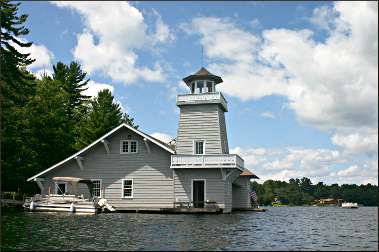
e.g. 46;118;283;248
183;67;222;94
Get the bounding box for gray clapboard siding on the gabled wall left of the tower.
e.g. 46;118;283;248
39;128;173;210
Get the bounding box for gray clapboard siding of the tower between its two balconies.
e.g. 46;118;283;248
176;104;227;154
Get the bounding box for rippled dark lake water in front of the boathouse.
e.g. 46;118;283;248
1;207;378;250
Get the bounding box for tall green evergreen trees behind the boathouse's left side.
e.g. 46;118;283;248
0;1;138;194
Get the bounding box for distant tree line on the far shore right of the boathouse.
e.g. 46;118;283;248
251;177;378;206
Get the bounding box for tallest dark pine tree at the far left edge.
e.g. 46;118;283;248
0;0;35;191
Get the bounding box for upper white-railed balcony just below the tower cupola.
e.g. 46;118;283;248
176;92;228;111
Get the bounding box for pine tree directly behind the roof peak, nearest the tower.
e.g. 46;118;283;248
75;89;134;150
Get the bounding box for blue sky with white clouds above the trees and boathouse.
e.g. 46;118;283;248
20;1;378;185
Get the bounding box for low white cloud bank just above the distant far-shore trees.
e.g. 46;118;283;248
230;147;378;184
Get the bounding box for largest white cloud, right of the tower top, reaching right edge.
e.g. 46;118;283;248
182;2;378;159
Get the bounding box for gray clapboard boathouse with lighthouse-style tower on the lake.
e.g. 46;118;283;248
28;68;257;213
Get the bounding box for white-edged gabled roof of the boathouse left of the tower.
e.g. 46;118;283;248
27;123;175;181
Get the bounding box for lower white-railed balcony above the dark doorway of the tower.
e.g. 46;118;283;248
171;154;244;170
